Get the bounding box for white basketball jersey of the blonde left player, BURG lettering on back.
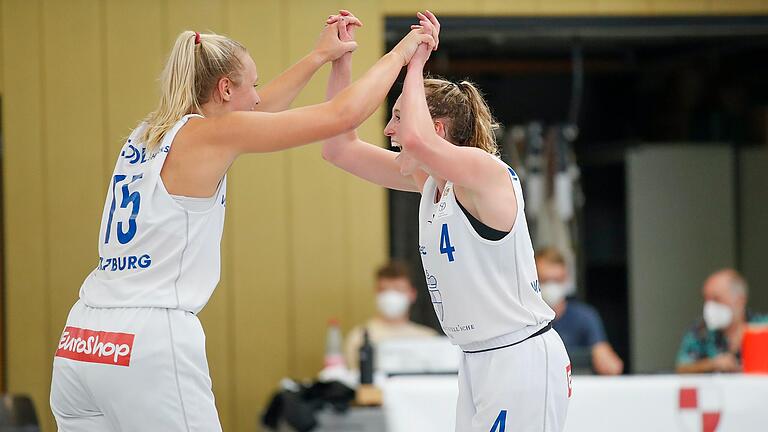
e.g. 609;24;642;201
80;115;227;313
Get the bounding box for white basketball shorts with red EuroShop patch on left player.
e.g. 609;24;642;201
50;301;221;432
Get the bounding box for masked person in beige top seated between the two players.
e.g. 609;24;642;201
344;261;437;369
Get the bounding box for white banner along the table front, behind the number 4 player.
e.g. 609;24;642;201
384;375;768;432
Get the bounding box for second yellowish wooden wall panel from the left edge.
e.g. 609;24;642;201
41;0;109;368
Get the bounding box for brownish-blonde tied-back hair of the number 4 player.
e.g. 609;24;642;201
424;78;499;155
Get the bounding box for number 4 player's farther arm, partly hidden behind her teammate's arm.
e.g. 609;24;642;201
322;11;419;192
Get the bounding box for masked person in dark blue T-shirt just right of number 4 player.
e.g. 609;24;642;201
535;248;624;375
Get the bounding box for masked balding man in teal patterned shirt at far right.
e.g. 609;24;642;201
677;269;768;373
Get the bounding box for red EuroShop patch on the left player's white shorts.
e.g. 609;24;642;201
56;327;135;366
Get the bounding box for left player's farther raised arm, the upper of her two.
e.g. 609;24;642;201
256;16;362;112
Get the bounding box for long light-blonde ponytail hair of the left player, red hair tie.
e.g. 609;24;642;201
139;31;246;153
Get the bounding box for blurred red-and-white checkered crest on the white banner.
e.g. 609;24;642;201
678;385;722;432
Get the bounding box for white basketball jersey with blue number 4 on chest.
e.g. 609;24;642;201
419;161;555;345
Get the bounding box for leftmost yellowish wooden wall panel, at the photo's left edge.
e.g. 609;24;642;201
2;0;50;430
